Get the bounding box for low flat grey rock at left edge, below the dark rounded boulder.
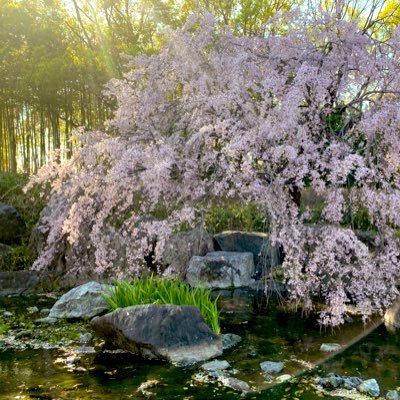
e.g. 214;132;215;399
0;271;43;296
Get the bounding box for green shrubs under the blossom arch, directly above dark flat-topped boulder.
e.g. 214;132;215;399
204;200;265;233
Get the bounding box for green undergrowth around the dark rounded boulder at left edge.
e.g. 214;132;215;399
0;172;45;271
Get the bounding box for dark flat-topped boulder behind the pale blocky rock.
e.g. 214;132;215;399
213;231;282;274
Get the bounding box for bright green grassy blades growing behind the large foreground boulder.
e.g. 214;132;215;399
104;275;220;334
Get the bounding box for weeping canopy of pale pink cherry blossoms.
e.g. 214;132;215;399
31;8;400;325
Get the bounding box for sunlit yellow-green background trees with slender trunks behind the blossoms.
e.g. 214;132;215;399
0;0;400;173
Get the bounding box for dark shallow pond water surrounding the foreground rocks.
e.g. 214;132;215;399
0;291;400;400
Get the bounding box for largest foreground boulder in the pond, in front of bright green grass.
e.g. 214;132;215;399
90;304;222;365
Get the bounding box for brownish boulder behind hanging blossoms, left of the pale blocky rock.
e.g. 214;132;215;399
162;228;214;278
